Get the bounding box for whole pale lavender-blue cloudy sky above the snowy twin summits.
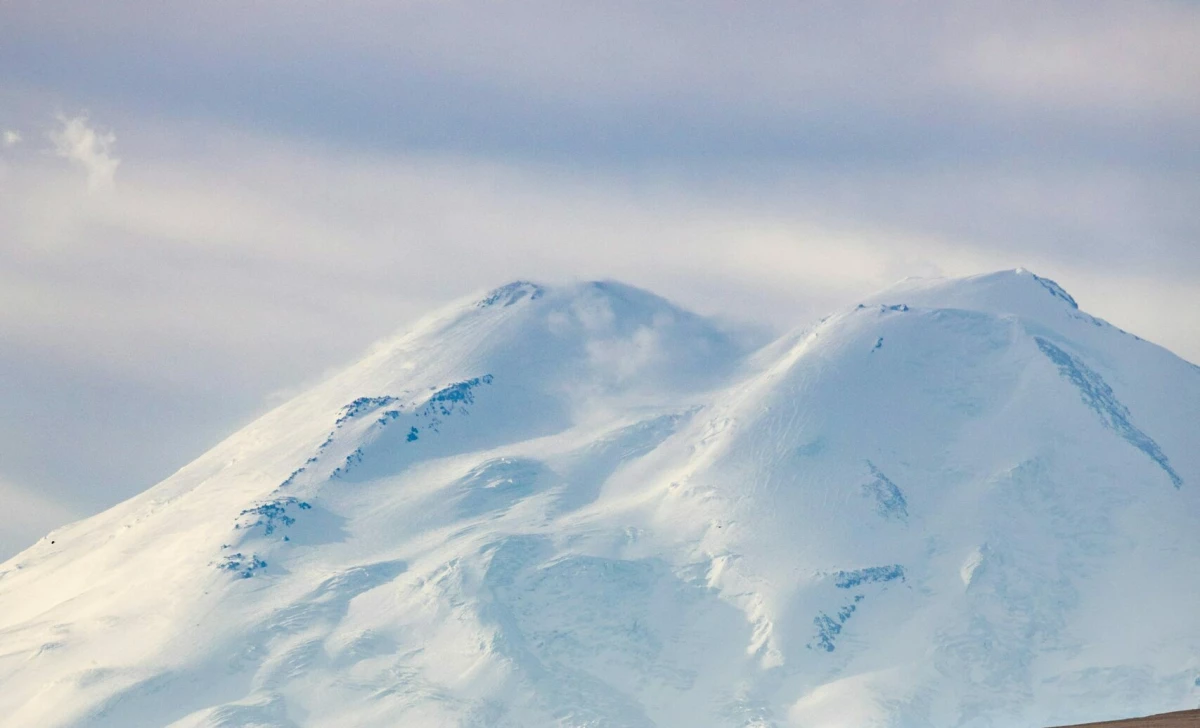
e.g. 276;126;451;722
0;0;1200;558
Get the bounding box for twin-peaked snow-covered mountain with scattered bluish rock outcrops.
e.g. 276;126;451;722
0;271;1200;728
